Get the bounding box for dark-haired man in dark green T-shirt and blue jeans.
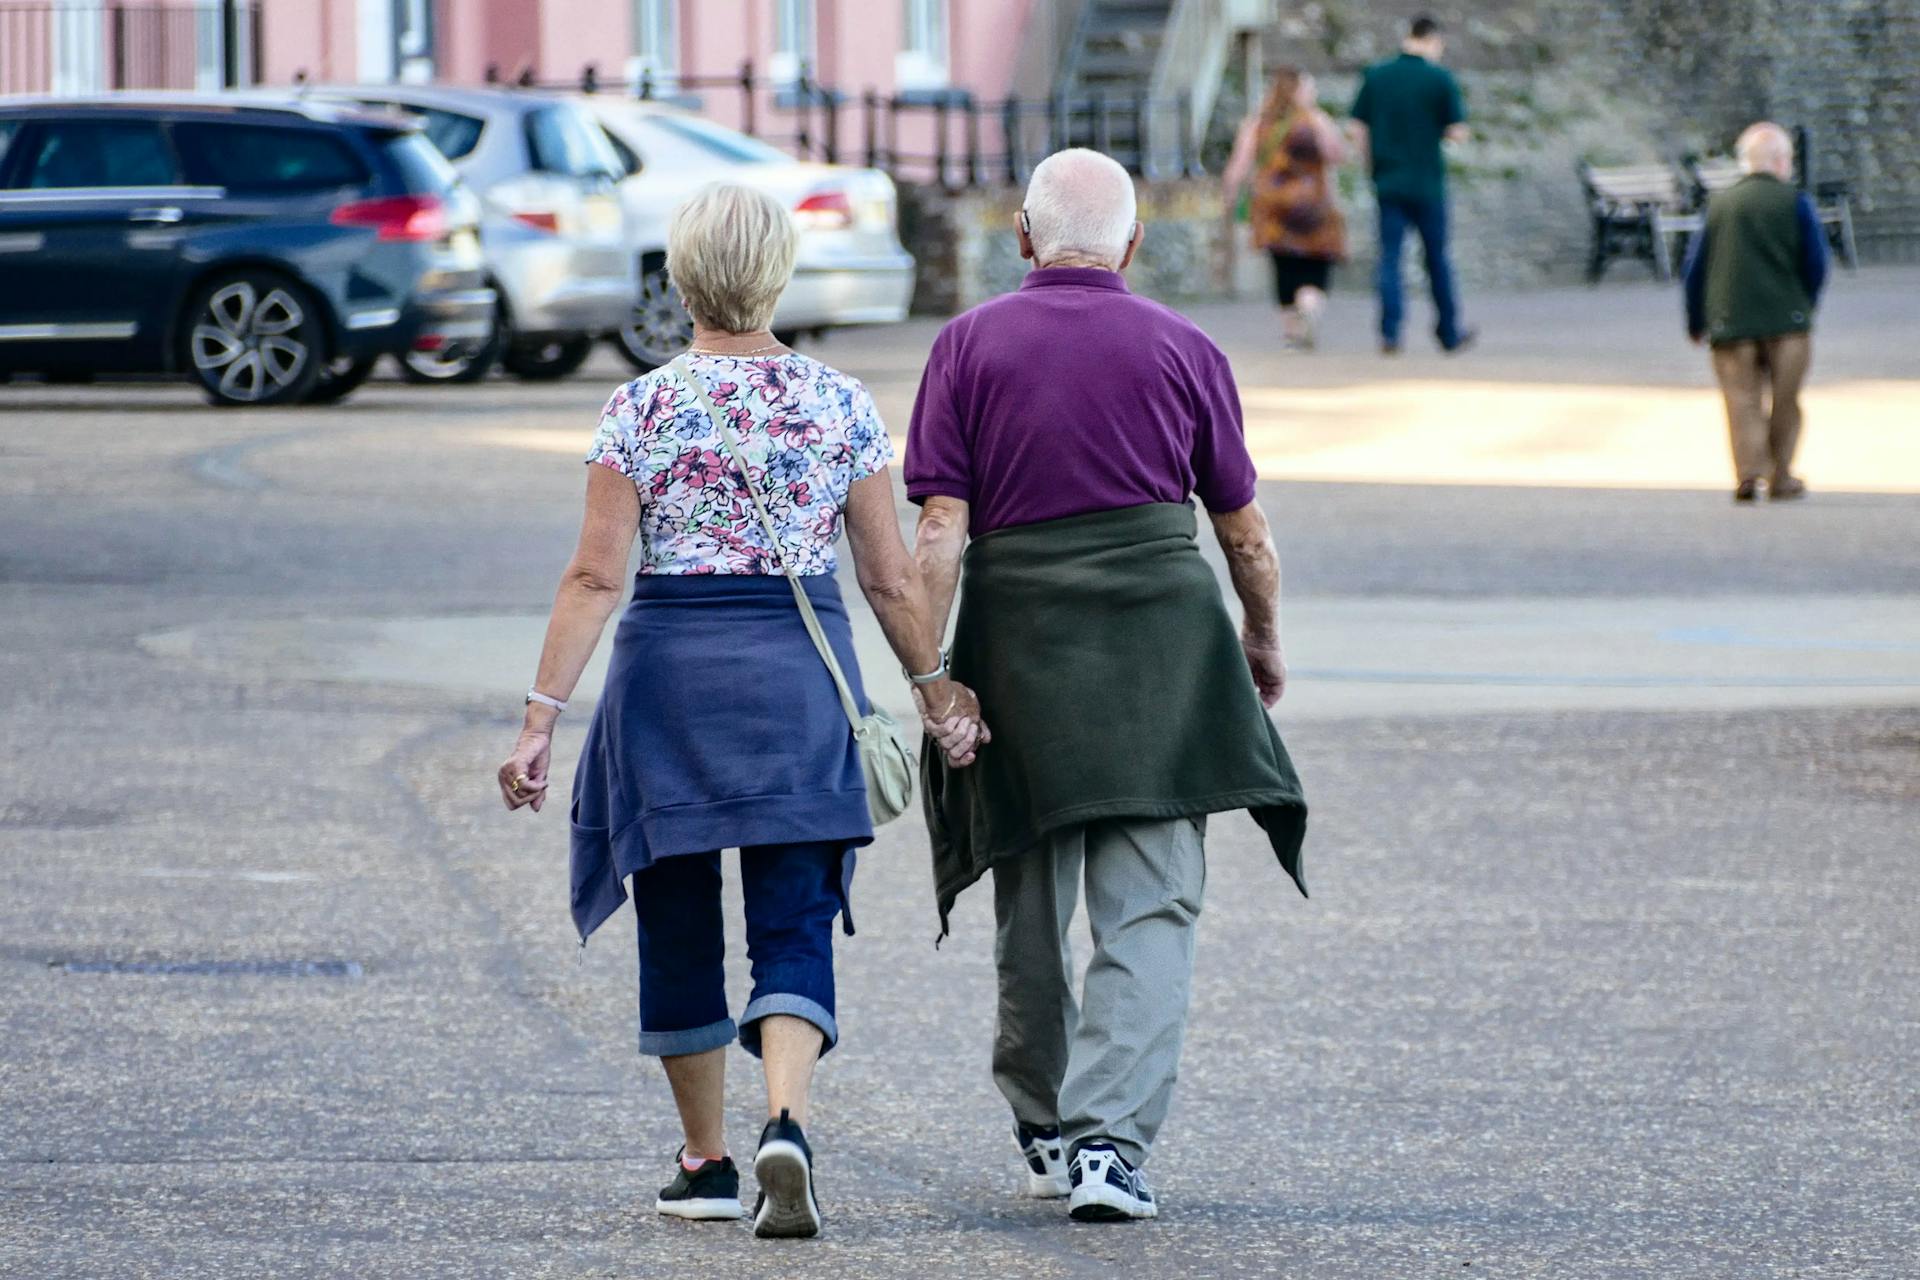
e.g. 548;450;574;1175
1352;17;1475;355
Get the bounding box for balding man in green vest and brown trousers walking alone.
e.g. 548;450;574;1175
1686;121;1826;503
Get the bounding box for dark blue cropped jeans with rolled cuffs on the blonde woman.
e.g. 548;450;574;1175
634;844;854;1057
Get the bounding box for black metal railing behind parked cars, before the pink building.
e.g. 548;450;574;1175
486;61;1208;190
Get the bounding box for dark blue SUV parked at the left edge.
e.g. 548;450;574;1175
0;96;493;405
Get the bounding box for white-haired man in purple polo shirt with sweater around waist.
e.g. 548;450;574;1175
906;150;1306;1221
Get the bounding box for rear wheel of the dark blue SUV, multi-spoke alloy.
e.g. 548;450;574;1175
184;267;323;405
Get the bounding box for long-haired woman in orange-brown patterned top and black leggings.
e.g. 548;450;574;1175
1223;67;1346;351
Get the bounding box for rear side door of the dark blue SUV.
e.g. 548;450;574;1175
0;113;221;372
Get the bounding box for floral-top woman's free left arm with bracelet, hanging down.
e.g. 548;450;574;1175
499;466;639;814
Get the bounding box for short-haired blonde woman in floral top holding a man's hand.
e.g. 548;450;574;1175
499;186;987;1236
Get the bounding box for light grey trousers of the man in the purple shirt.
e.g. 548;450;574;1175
993;818;1206;1165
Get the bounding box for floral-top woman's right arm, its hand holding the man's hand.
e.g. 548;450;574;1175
847;468;993;764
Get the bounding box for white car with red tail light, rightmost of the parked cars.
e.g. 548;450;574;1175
576;98;914;370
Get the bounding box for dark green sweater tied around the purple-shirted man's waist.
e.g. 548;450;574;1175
924;503;1308;933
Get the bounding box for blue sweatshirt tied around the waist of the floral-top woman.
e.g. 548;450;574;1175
572;574;874;942
